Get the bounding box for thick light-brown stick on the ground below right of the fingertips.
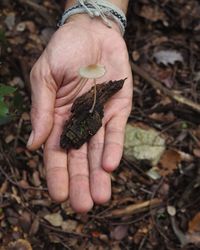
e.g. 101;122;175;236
108;198;162;217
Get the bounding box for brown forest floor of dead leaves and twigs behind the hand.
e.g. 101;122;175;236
0;0;200;250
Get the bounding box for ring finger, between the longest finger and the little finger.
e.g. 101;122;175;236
88;127;111;204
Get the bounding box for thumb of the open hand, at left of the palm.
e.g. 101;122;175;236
27;57;57;150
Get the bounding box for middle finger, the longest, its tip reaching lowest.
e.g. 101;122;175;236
68;144;93;213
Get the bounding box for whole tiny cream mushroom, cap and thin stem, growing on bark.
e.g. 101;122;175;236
79;64;106;113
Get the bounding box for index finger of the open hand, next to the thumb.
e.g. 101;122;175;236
44;119;69;202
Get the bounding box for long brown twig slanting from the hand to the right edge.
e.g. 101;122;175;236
130;62;200;113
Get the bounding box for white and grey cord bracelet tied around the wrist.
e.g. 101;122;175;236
58;0;127;35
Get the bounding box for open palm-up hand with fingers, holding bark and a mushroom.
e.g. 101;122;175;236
27;15;132;212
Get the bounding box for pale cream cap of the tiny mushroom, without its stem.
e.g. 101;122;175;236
79;64;106;79
